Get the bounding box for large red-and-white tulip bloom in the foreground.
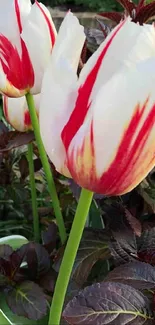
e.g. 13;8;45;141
40;14;155;195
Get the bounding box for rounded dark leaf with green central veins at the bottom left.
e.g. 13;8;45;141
6;281;47;320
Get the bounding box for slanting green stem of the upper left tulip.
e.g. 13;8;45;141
26;94;67;243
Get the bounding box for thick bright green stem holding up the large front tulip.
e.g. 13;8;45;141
48;189;93;325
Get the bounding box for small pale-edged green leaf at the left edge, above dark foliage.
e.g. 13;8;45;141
0;235;28;250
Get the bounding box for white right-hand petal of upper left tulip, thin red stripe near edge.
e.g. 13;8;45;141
21;3;56;94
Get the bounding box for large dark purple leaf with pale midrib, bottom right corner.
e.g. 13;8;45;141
63;282;154;325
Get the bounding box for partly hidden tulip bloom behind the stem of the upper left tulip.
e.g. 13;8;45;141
3;94;40;132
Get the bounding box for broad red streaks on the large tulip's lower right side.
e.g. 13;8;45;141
99;100;155;195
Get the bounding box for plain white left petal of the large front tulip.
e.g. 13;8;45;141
40;12;85;176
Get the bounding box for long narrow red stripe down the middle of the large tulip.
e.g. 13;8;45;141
61;20;125;151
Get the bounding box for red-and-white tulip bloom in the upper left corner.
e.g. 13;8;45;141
0;0;56;97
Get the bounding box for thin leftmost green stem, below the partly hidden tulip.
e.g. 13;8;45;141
27;143;40;242
